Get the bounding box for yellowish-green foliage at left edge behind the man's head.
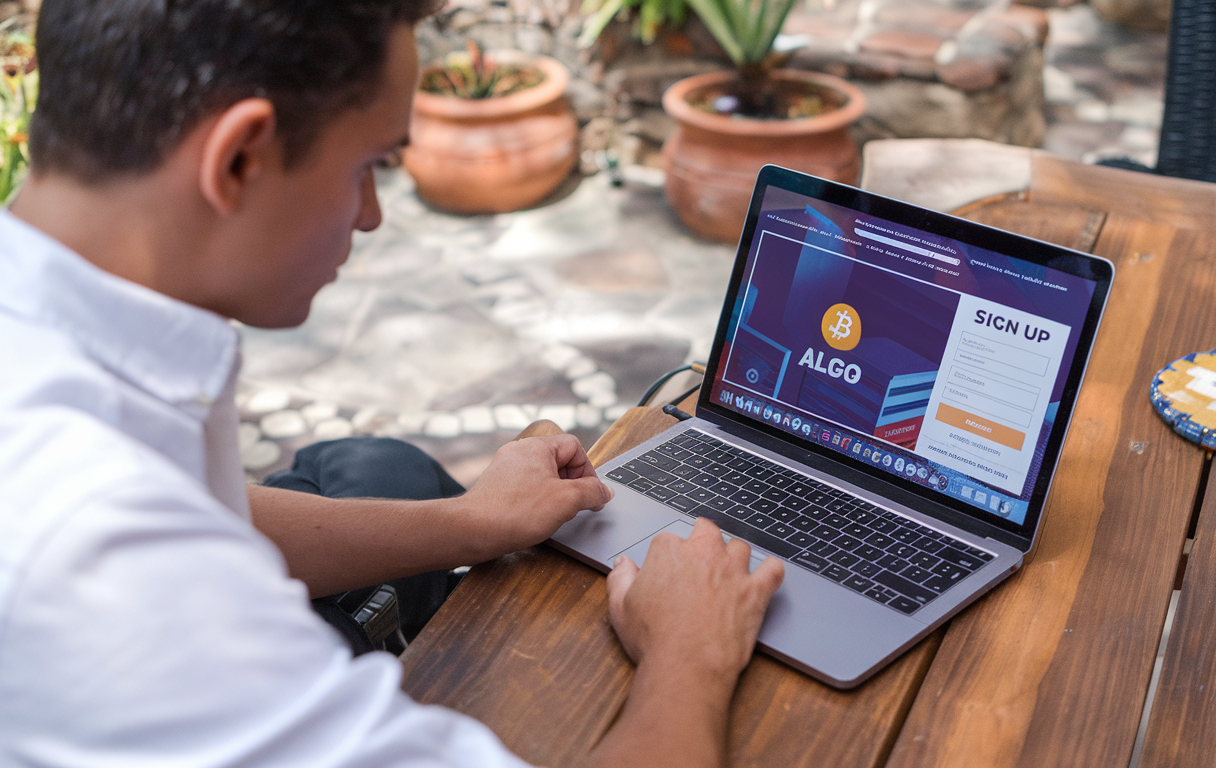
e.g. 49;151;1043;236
0;23;38;205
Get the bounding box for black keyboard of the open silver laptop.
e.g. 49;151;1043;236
608;430;993;614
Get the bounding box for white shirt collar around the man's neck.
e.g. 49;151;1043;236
0;204;238;408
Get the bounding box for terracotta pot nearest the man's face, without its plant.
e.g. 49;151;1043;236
405;52;579;214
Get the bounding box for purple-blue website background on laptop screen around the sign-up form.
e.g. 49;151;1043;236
711;187;1094;523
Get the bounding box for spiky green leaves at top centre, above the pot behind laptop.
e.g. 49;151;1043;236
579;0;834;114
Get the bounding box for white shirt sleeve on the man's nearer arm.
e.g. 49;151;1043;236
0;435;537;768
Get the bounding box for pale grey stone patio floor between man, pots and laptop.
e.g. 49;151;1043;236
237;5;1166;485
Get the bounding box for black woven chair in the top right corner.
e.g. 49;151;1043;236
1102;0;1216;181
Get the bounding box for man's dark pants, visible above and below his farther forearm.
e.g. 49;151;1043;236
264;437;465;640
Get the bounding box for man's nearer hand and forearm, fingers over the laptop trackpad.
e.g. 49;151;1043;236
584;520;786;768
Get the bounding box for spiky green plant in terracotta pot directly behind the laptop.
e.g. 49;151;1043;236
582;0;866;242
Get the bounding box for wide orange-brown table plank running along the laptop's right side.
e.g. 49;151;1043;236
889;211;1216;768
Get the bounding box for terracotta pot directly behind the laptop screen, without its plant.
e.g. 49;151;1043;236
663;69;866;243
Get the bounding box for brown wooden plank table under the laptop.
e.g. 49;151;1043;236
402;154;1216;768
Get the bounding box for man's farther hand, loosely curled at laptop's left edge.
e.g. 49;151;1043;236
462;435;613;559
